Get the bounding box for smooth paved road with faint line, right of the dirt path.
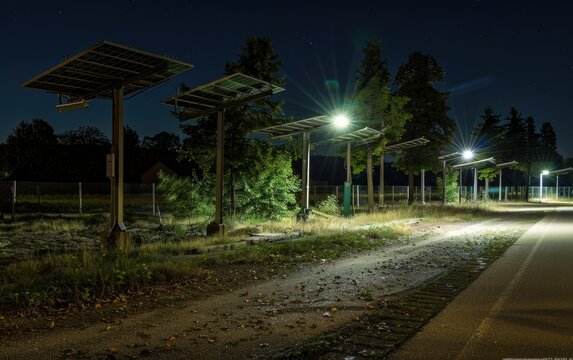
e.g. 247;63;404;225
392;207;573;360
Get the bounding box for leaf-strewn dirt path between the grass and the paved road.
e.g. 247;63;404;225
0;218;531;359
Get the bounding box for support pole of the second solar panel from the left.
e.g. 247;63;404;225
207;110;225;235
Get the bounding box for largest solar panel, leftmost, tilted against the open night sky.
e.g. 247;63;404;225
22;41;193;100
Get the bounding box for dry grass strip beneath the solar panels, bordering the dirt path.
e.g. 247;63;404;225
0;205;515;310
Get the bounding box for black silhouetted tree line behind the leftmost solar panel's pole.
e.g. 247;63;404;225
0;119;181;183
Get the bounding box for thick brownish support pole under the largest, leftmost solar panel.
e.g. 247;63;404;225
108;86;126;233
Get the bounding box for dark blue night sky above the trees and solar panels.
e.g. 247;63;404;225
0;0;573;157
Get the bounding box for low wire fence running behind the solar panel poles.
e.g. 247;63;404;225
0;181;573;217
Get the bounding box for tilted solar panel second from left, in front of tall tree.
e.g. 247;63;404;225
162;73;284;119
